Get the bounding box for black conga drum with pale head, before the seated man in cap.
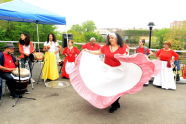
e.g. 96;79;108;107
11;68;30;95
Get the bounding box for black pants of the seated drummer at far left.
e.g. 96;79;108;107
0;72;15;96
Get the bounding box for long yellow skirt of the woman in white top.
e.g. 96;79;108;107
42;41;59;80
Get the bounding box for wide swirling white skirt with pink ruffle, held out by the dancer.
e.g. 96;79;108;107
70;52;161;109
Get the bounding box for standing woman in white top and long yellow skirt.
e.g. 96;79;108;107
42;33;60;82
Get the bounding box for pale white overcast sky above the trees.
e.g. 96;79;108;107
24;0;186;30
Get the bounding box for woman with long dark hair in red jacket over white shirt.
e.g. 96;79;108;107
18;33;35;72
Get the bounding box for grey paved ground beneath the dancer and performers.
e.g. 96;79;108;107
0;63;186;124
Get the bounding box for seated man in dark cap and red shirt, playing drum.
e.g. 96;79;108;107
0;44;16;97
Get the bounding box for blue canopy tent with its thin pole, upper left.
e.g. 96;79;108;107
0;0;66;47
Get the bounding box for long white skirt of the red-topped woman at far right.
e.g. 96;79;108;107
153;61;176;90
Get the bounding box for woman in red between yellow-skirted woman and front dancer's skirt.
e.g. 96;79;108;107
61;40;80;78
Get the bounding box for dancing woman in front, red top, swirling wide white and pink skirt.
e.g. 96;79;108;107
70;33;158;113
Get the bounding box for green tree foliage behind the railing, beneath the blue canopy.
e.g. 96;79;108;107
0;21;56;41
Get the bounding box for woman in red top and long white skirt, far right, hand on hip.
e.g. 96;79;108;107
153;42;179;90
